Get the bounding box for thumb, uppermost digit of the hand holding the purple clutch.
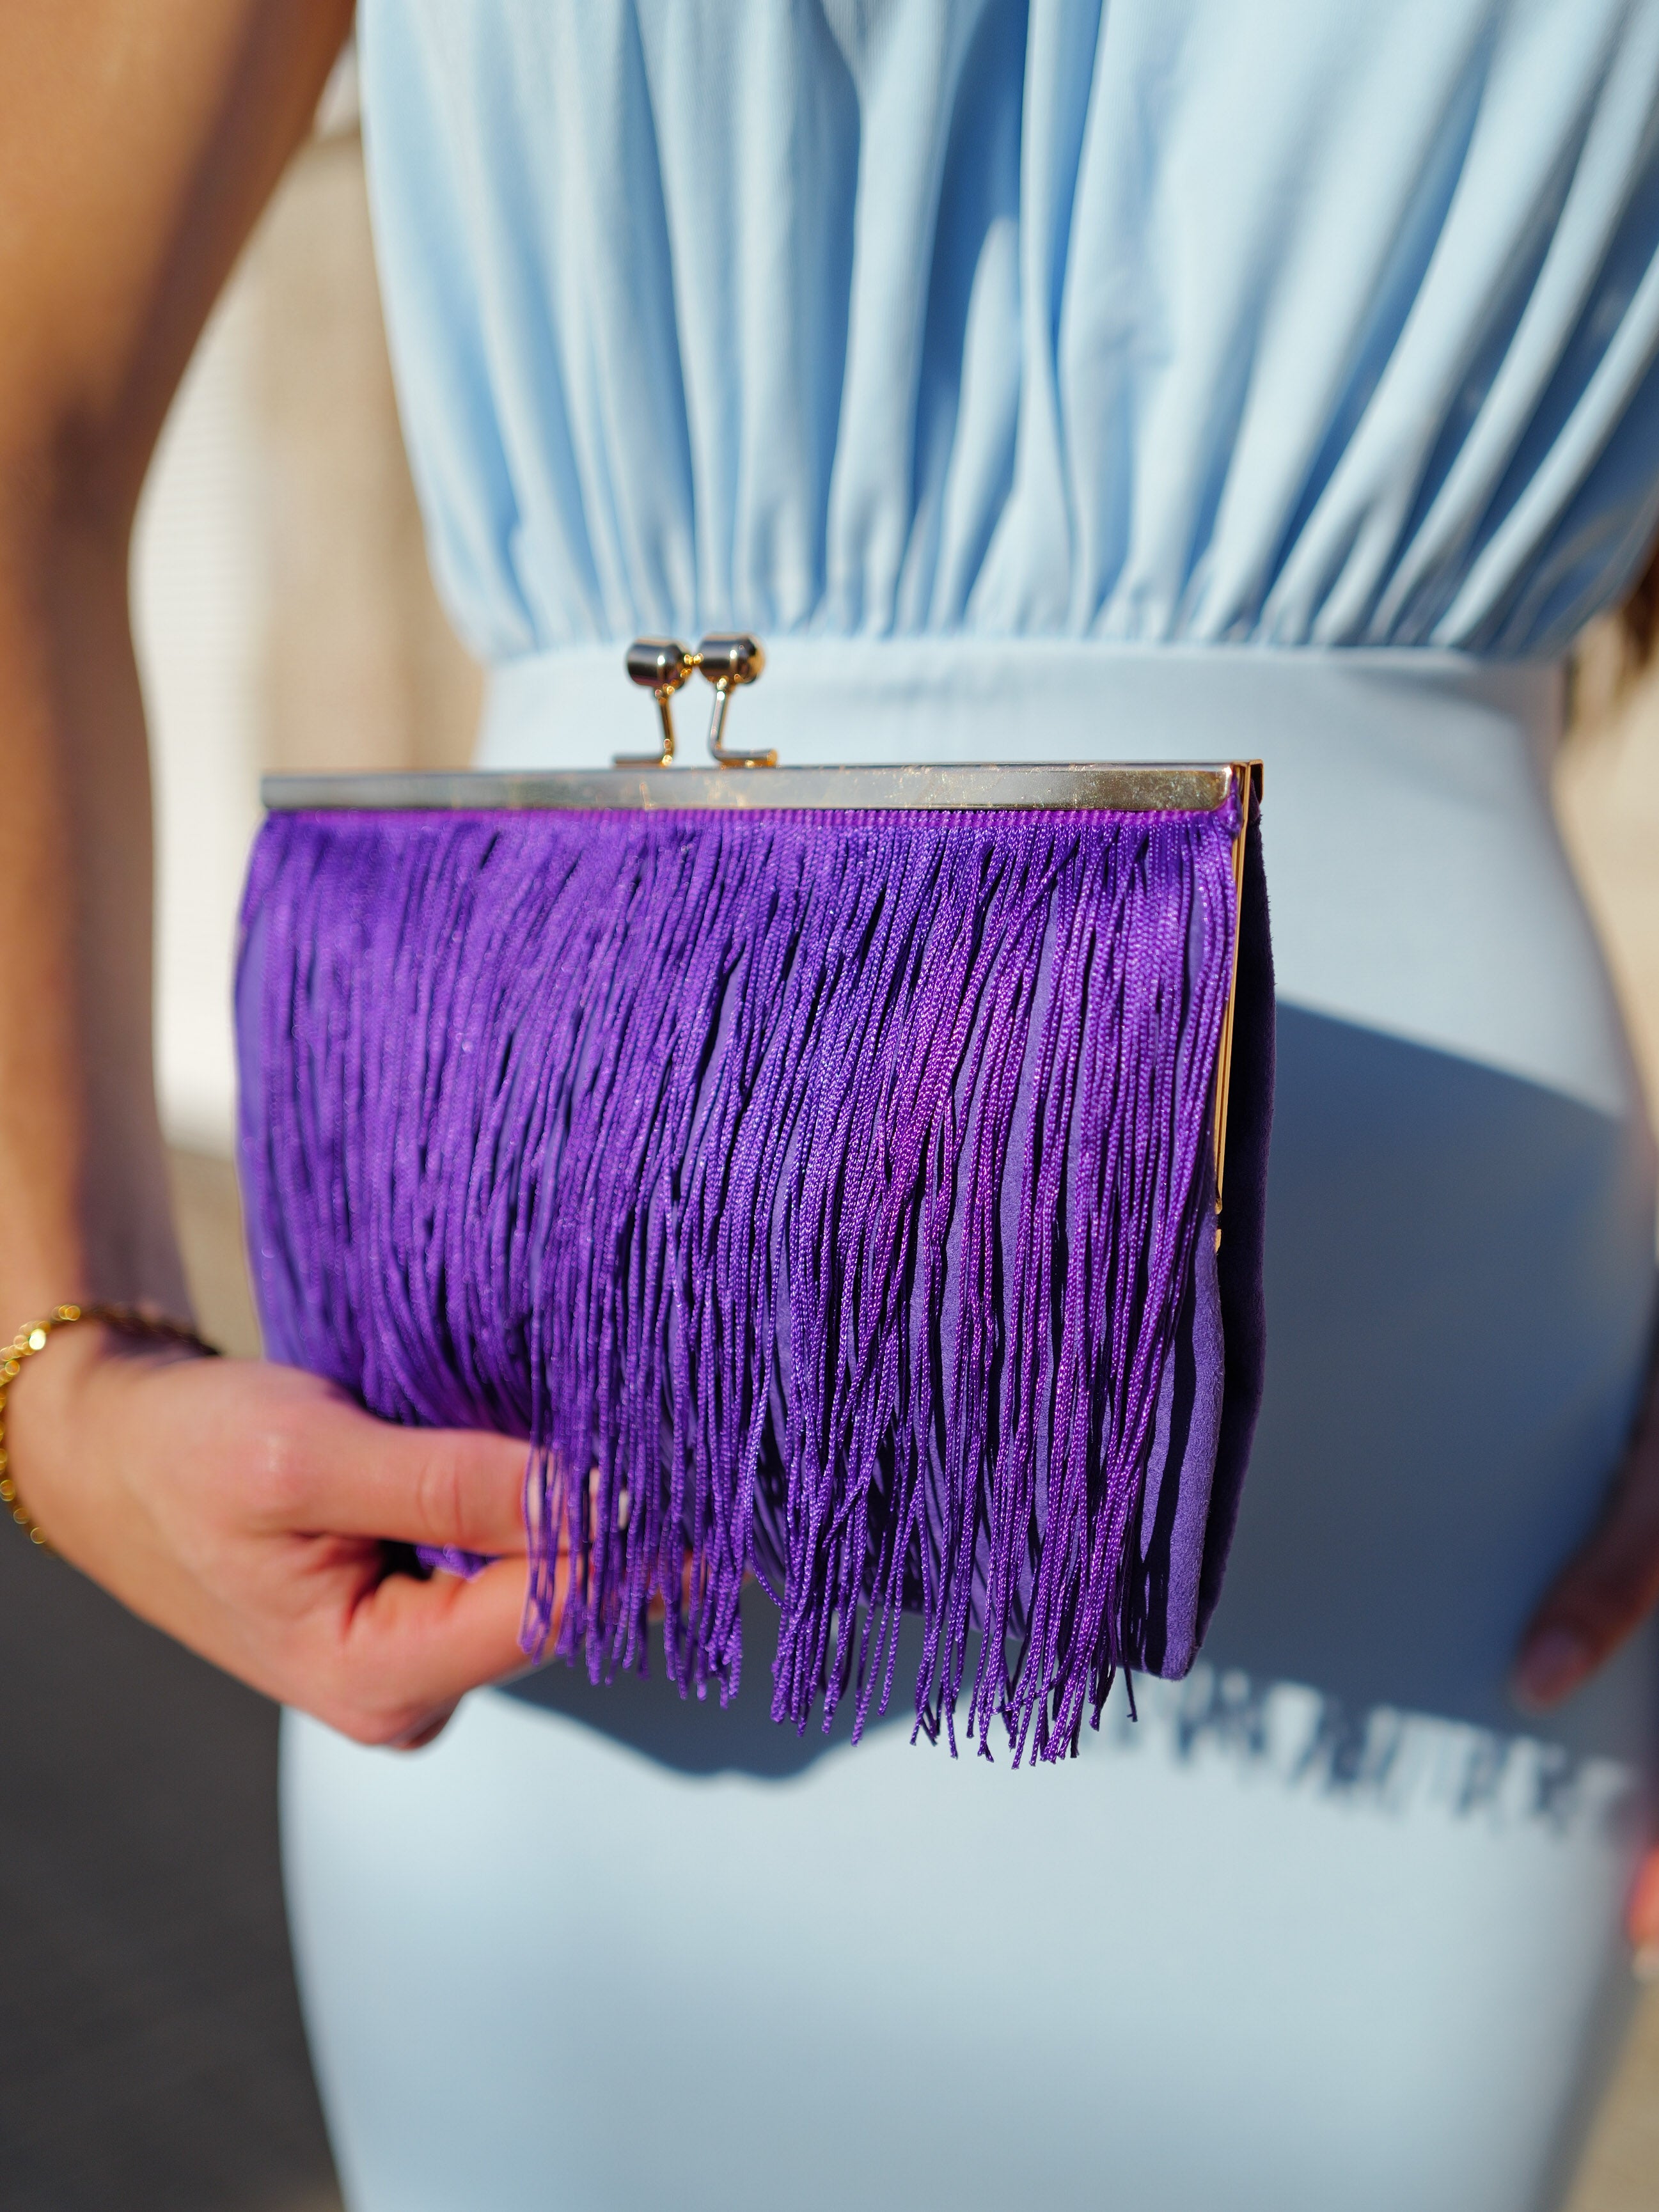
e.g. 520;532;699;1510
272;1402;529;1555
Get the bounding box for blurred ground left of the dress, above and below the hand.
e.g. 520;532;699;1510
0;1157;338;2212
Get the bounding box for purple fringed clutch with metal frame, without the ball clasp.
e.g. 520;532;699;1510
237;767;1272;1759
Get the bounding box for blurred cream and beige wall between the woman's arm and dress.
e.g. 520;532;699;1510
133;59;482;1349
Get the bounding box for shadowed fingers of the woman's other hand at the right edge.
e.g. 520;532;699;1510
1515;1418;1659;1707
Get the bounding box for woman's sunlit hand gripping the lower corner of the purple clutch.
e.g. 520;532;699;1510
4;1322;526;1745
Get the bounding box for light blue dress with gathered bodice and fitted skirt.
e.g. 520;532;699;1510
285;0;1659;2212
